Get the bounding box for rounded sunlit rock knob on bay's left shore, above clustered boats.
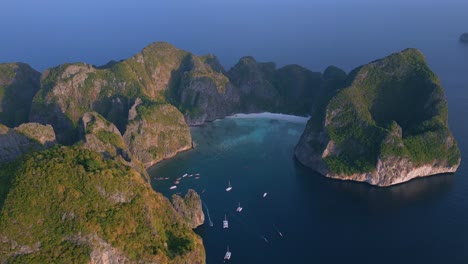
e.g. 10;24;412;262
123;104;192;167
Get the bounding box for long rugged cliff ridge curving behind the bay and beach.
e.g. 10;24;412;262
30;43;330;135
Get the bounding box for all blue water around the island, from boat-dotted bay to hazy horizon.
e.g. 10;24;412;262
0;0;468;263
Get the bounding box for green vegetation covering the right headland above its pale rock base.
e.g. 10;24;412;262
315;49;460;175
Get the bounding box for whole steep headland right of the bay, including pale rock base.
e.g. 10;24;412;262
295;49;461;186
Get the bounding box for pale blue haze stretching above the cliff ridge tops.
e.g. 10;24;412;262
0;0;468;71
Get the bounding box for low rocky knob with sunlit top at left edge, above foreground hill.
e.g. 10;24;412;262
0;123;56;162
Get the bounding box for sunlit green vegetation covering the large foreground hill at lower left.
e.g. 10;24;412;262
0;146;204;263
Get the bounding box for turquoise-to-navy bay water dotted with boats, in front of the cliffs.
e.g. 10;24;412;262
150;118;468;263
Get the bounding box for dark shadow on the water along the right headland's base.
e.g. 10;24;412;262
296;161;455;214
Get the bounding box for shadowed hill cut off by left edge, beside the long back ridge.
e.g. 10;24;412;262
0;63;40;127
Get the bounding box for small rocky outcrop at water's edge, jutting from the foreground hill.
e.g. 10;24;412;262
172;189;205;228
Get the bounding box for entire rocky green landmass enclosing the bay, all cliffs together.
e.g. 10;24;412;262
0;42;461;263
